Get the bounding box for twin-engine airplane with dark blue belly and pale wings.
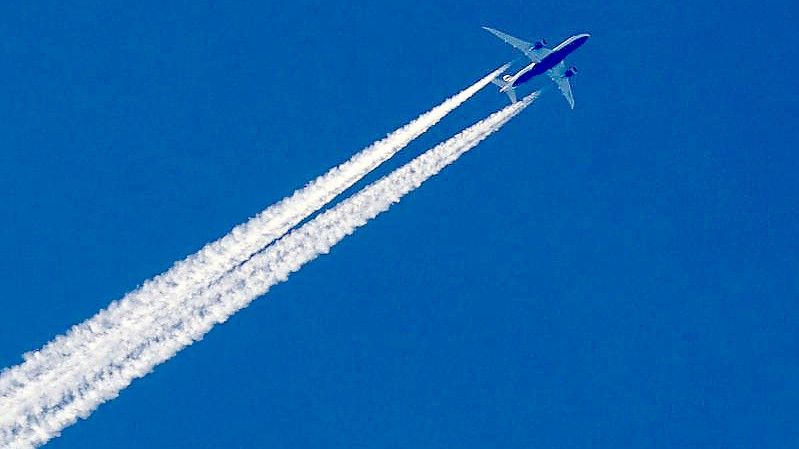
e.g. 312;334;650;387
483;27;591;109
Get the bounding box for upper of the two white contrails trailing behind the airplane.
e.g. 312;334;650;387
0;66;506;417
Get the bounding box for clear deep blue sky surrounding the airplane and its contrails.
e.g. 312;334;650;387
0;0;799;449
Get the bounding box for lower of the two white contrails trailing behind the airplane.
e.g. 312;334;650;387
0;93;538;448
